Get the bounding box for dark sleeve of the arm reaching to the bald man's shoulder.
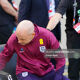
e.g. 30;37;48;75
56;0;70;15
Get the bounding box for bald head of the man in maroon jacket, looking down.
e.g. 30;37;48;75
16;20;35;45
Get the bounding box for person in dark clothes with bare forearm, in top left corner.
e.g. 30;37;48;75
0;0;18;44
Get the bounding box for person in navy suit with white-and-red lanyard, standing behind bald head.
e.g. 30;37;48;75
18;0;61;41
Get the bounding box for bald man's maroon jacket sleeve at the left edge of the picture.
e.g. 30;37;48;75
0;36;15;70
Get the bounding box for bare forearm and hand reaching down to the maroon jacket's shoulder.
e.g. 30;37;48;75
47;13;62;30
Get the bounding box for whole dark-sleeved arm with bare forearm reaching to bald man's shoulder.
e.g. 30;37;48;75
47;0;69;30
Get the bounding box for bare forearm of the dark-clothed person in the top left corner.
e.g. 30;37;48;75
0;0;17;17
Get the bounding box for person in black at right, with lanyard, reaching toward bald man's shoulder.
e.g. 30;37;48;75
47;0;80;80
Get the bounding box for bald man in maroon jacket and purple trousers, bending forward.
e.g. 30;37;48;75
0;20;68;80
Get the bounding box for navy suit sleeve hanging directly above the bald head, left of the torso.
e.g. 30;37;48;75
18;0;31;23
